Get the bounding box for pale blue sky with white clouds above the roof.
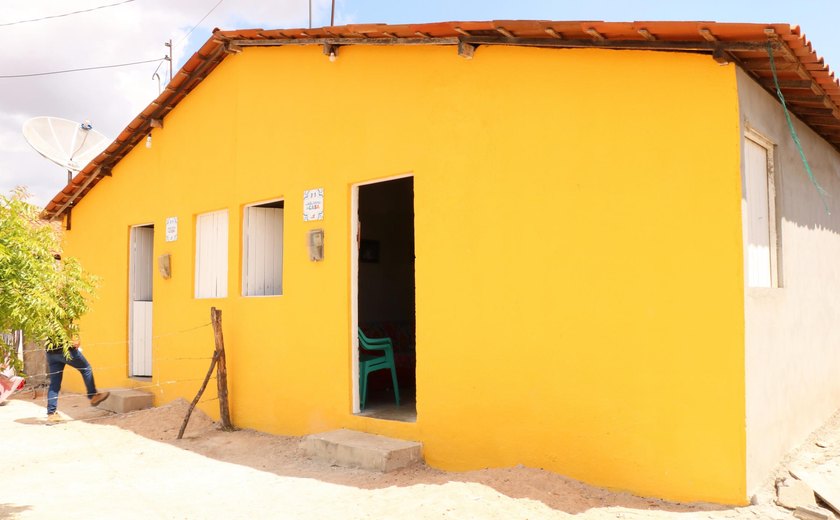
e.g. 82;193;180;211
0;0;840;204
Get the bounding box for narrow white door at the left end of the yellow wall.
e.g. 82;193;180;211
128;226;155;377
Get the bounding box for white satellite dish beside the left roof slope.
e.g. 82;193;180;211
23;117;110;177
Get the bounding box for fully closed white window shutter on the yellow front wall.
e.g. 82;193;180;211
195;209;229;299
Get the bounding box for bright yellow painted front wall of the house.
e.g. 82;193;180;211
62;46;746;503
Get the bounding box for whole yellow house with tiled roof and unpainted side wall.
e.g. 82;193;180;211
44;21;840;504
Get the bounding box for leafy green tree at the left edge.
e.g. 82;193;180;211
0;188;96;370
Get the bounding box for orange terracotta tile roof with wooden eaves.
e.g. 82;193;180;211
42;20;840;219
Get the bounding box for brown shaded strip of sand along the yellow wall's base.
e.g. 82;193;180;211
11;393;732;517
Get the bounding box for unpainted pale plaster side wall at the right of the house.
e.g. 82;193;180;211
738;70;840;493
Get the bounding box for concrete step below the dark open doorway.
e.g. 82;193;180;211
301;430;423;473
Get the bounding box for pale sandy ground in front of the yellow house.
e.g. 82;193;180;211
0;391;840;520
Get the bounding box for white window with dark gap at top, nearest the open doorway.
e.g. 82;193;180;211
242;199;286;298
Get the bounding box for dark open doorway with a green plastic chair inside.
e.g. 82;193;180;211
353;177;417;421
